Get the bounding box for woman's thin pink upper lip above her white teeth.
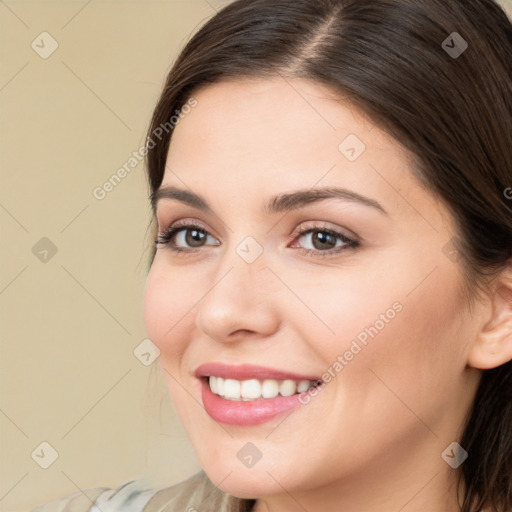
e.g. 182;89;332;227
194;362;320;381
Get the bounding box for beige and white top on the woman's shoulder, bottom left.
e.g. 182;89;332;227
30;471;254;512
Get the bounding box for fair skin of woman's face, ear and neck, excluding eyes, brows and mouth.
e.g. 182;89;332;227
144;78;512;512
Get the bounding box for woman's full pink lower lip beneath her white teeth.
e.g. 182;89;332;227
201;379;302;426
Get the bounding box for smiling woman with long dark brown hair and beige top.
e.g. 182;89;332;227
36;0;512;512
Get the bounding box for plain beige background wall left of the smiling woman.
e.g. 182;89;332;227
0;0;512;512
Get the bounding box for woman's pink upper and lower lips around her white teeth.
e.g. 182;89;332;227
195;363;320;426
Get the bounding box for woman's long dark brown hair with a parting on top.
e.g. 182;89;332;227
147;0;512;512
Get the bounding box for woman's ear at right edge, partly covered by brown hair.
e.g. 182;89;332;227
468;262;512;370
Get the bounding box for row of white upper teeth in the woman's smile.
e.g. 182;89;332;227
209;375;316;401
